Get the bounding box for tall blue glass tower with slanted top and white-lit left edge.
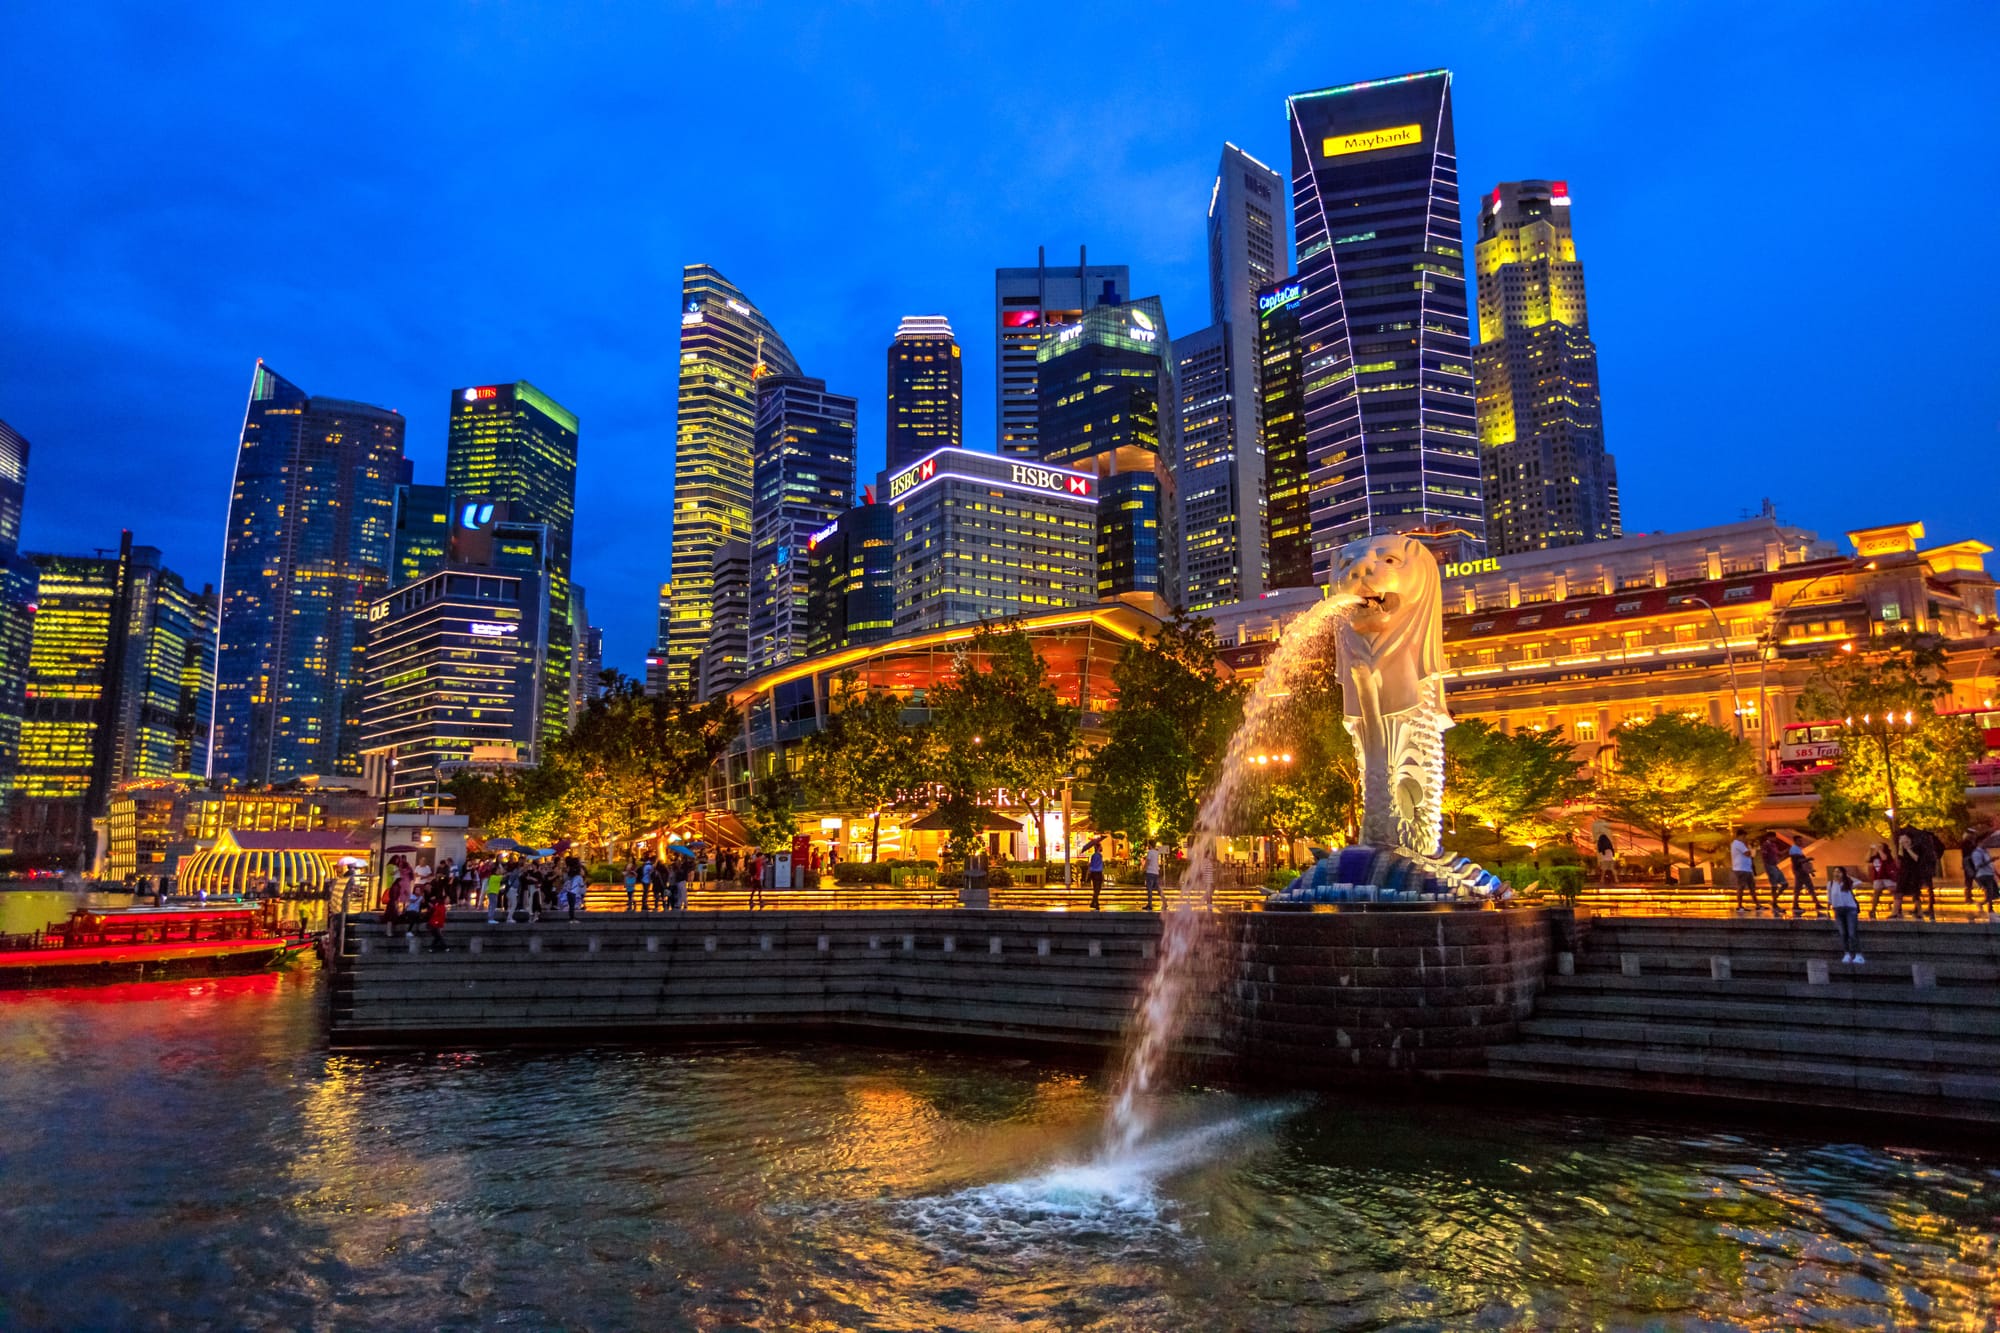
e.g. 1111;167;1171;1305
210;360;404;785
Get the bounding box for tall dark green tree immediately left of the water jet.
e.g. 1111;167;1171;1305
1090;612;1244;845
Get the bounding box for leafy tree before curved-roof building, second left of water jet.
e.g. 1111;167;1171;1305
926;626;1080;861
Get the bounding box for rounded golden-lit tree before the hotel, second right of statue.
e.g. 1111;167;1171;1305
1598;713;1764;857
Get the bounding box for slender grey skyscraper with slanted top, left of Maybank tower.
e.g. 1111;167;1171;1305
1174;144;1284;610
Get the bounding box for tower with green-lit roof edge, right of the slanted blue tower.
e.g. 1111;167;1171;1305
444;380;578;741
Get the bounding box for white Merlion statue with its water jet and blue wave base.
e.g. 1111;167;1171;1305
1104;534;1494;1155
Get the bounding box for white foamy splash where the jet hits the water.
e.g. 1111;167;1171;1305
906;1103;1298;1257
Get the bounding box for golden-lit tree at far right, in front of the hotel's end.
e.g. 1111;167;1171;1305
1798;634;1986;847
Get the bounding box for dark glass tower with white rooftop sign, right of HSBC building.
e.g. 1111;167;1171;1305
1040;296;1180;600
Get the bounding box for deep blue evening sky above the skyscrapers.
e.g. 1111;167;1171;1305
0;0;2000;671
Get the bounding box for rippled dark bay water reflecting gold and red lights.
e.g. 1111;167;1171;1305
0;960;2000;1329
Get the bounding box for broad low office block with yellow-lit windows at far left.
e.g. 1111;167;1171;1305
10;532;216;867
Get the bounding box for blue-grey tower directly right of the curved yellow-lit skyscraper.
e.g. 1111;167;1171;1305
750;374;858;671
